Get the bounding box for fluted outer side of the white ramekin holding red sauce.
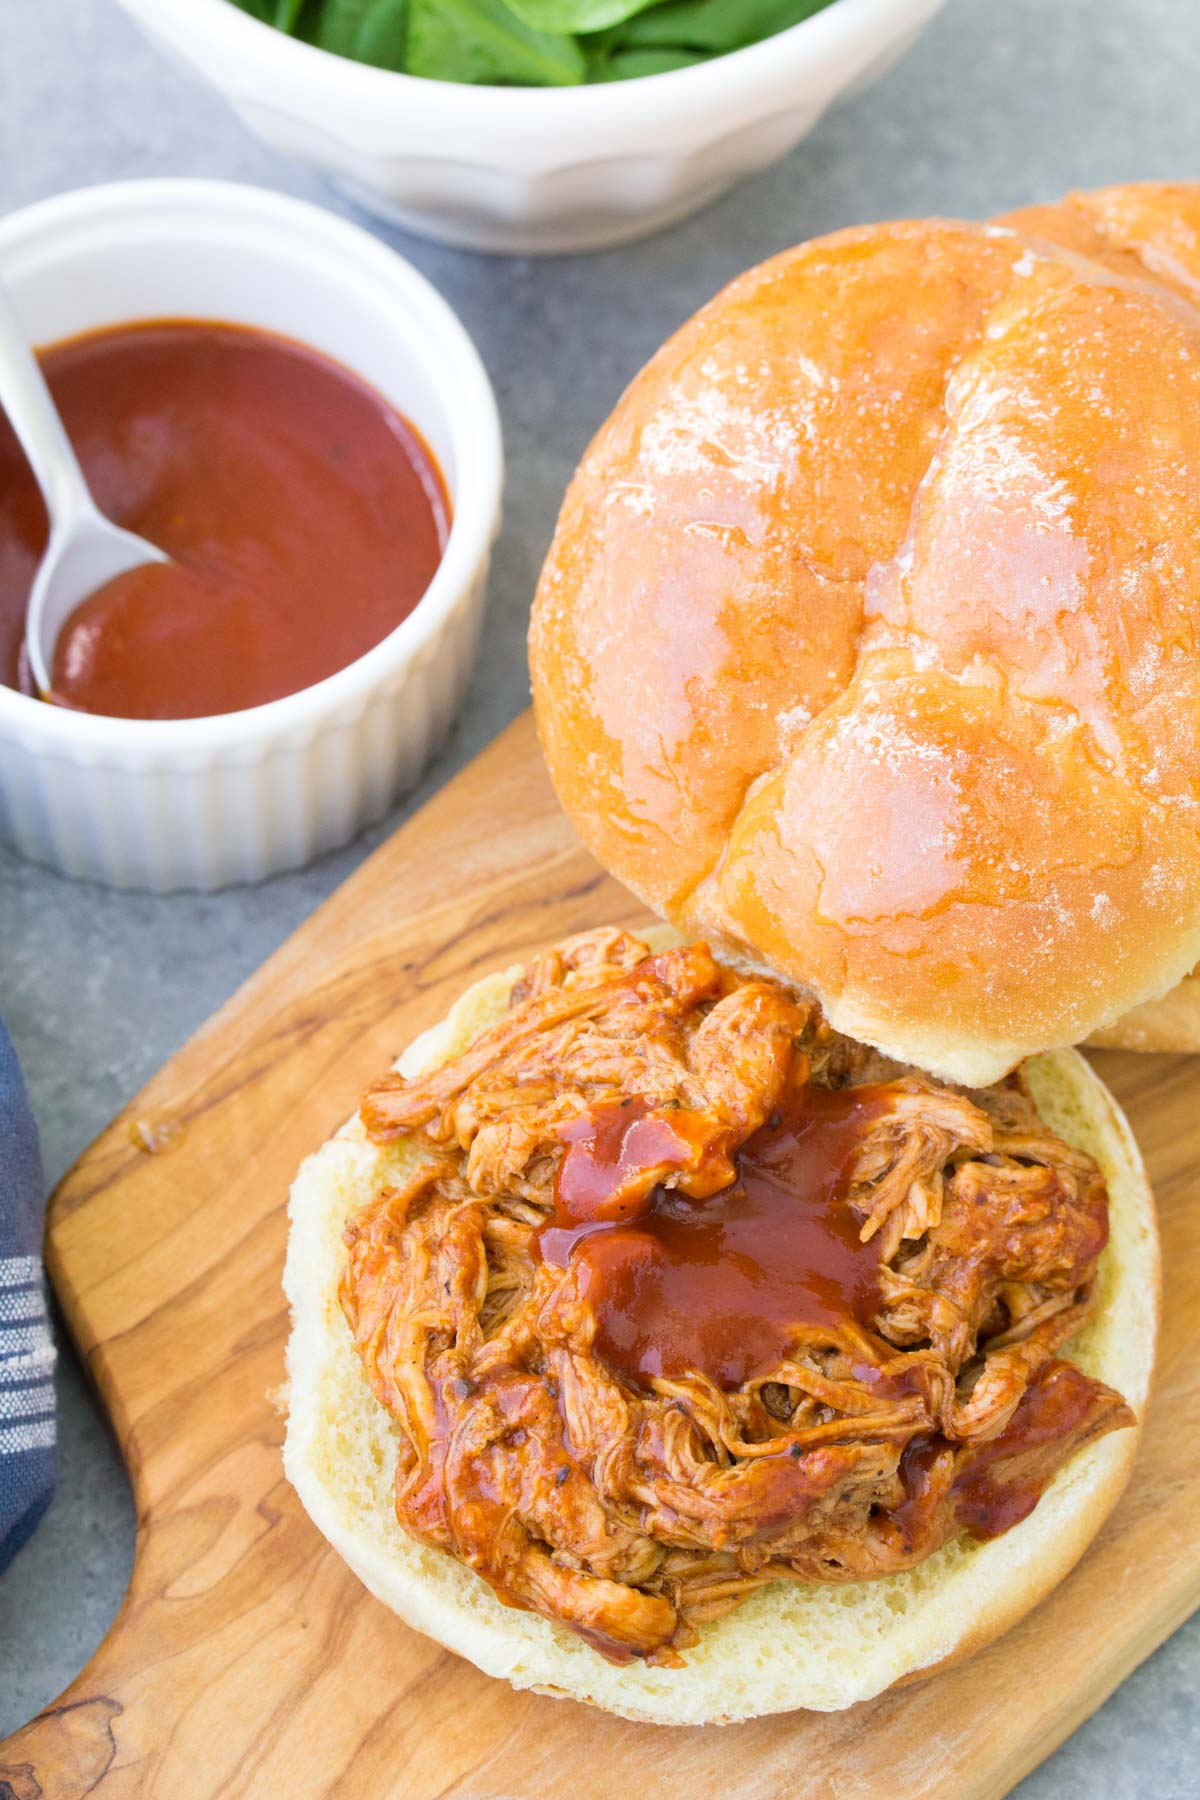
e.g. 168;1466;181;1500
0;558;488;893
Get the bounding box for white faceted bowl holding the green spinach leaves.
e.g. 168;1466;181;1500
119;0;945;254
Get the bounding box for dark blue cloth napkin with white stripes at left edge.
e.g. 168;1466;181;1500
0;1026;54;1571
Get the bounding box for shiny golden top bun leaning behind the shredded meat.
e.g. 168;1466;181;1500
531;184;1200;1084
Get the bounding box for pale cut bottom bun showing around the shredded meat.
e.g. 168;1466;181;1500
284;943;1159;1724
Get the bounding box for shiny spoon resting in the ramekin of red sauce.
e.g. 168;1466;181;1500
0;284;171;695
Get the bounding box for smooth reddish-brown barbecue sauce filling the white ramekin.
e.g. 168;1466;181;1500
0;319;450;718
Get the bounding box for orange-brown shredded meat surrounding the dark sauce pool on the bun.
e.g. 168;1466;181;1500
340;931;1132;1665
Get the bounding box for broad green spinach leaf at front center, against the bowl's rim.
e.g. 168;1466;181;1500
407;0;587;88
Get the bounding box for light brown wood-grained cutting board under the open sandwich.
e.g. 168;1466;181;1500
0;718;1200;1800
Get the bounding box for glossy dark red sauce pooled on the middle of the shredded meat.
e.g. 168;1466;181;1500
534;1082;885;1391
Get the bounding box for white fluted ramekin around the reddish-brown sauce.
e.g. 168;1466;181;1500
0;182;502;891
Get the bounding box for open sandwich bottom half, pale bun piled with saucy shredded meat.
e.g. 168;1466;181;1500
286;931;1157;1723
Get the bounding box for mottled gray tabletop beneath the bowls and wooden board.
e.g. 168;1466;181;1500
0;0;1200;1800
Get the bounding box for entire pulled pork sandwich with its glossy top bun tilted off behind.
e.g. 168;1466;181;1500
286;185;1173;1723
